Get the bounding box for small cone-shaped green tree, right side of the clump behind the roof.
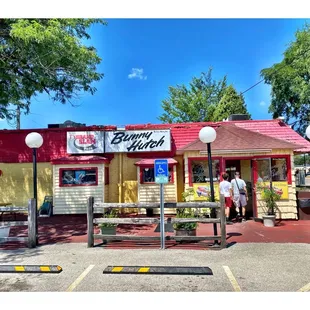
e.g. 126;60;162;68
212;85;251;122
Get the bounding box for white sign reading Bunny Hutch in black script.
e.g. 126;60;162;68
105;130;171;153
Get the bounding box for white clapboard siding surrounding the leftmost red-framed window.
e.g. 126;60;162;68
53;164;105;214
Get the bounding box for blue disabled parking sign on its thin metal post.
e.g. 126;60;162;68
154;159;169;250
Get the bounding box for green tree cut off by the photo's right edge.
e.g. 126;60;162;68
261;24;310;135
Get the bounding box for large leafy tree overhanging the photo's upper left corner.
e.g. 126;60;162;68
0;19;106;120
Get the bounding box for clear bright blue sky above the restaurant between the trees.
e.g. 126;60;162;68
0;19;306;129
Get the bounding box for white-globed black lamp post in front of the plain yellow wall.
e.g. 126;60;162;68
25;132;43;245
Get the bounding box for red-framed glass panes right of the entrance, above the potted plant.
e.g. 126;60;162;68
257;158;287;182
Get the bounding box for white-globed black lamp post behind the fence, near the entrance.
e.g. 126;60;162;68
199;127;218;245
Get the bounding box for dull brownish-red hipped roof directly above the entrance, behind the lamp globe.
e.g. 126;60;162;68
182;123;300;151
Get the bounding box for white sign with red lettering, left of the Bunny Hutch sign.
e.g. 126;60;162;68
67;131;104;154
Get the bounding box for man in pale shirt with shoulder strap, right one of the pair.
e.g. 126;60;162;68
231;172;248;222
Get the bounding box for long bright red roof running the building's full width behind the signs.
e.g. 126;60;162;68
0;120;310;163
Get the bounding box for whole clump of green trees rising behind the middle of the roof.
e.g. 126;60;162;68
159;68;248;123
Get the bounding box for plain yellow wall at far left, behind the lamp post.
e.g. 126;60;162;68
0;163;53;208
